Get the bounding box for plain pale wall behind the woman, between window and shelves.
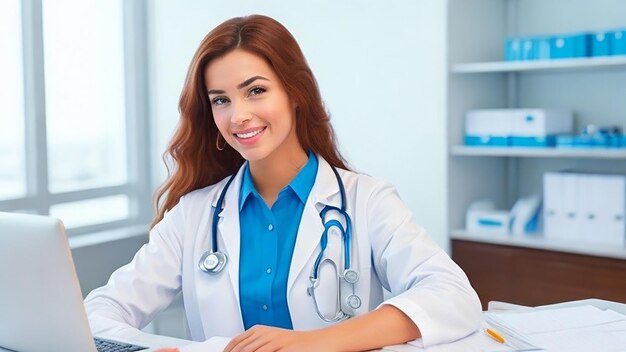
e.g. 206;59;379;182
149;0;448;249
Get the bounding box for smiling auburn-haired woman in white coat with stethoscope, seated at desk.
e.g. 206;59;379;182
85;16;481;352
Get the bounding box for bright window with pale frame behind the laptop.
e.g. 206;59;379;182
0;0;151;235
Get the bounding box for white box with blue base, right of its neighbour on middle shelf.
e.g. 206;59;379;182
505;109;574;147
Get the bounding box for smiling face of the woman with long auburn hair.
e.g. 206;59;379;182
204;49;302;167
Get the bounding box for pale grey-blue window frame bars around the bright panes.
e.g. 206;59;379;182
0;0;152;236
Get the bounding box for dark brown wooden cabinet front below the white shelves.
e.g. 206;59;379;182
452;240;626;309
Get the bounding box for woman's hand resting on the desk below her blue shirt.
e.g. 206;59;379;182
224;325;333;352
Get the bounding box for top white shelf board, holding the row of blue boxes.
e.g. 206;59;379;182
451;56;626;73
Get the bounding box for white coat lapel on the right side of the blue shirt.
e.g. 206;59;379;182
287;155;340;297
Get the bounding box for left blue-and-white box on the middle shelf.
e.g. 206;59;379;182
465;109;513;147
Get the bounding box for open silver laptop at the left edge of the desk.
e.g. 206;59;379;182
0;212;148;352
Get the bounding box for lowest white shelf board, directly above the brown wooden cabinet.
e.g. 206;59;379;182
450;229;626;259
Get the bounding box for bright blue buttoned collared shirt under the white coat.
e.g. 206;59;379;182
239;152;318;330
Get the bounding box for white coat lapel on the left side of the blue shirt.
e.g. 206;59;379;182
213;163;245;304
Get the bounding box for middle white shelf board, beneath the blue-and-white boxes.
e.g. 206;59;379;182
451;145;626;159
